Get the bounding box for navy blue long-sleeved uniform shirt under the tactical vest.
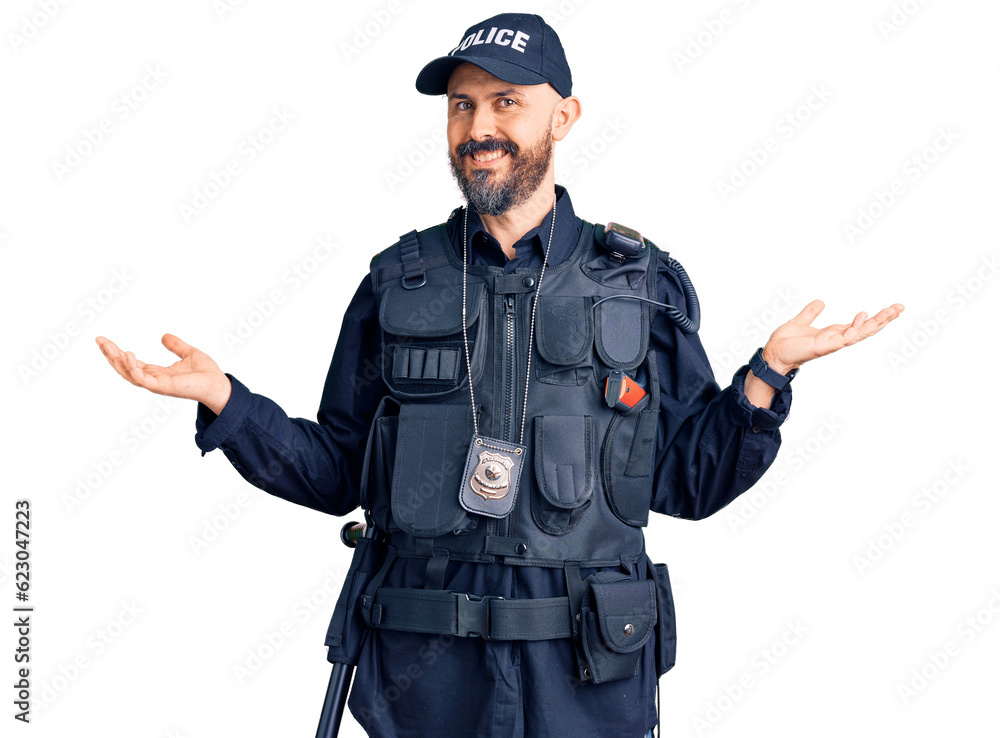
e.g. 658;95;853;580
195;186;791;738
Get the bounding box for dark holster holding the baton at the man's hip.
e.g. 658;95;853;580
325;538;386;664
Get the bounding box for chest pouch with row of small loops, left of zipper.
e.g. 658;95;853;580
379;282;489;399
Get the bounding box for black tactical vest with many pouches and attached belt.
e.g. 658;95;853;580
327;214;674;681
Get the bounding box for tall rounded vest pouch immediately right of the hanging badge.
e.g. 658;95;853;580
531;415;596;536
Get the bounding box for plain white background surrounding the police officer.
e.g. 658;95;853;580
0;0;1000;738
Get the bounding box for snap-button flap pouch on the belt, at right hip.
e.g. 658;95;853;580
580;572;656;684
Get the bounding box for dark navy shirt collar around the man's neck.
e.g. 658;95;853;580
447;185;582;273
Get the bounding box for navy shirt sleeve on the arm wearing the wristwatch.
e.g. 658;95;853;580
650;253;792;520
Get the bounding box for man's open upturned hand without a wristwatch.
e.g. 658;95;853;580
95;333;232;415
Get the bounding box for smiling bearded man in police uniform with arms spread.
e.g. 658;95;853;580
97;14;903;738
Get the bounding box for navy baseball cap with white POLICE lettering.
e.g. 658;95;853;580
417;13;573;97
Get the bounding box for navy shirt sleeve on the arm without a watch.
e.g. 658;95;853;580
195;277;385;515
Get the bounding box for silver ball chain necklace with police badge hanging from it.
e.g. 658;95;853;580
459;196;556;518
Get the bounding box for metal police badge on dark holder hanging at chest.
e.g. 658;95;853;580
458;435;528;518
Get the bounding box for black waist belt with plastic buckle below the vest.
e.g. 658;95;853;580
371;587;573;641
